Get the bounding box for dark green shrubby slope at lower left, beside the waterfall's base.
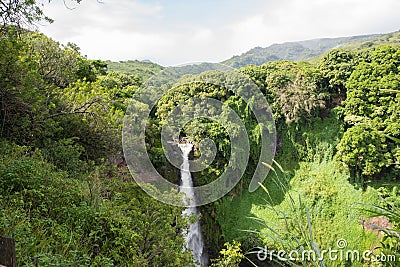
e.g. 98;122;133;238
0;141;191;266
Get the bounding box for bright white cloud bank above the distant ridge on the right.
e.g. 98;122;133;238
225;0;400;56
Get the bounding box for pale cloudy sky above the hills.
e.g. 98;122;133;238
39;0;400;66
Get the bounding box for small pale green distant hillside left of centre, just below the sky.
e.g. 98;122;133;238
106;60;163;80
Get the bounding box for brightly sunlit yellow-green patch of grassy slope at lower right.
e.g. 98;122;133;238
234;161;379;267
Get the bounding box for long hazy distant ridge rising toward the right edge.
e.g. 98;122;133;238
222;31;400;68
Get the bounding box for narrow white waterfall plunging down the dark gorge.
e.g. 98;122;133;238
179;143;208;266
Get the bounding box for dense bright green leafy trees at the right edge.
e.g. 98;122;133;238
337;46;400;180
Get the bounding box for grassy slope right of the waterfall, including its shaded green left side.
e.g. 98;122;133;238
217;115;379;266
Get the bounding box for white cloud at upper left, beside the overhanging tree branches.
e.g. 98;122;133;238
41;0;162;39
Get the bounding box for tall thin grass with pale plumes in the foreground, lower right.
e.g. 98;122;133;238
244;161;326;267
